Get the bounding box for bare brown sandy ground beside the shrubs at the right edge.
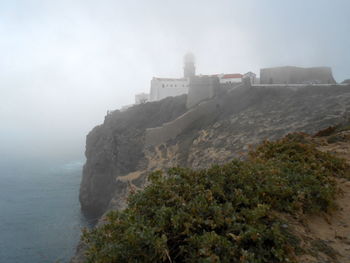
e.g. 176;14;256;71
292;131;350;263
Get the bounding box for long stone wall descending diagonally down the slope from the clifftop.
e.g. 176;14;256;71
145;82;347;147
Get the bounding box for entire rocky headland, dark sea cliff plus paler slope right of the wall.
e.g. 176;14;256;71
80;86;350;220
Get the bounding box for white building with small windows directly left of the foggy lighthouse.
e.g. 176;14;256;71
149;77;190;101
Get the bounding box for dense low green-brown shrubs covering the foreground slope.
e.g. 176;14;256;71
83;134;348;263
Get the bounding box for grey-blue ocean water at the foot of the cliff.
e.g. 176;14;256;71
0;161;87;263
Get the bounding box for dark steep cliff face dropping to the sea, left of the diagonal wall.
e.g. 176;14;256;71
79;96;186;218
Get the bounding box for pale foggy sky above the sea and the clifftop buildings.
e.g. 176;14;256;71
0;0;350;161
